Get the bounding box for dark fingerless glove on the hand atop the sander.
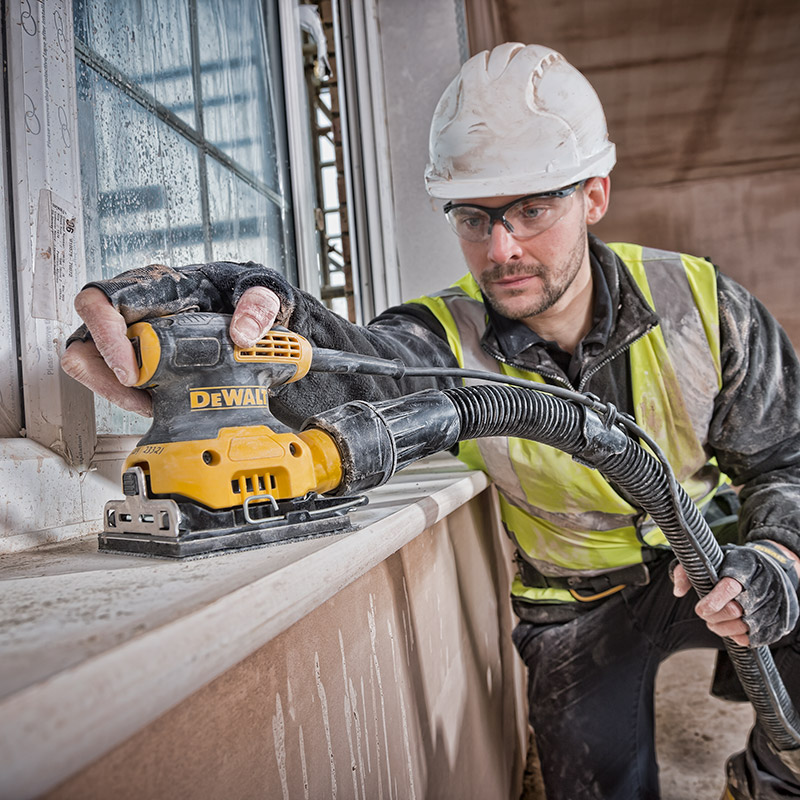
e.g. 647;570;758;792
67;261;296;345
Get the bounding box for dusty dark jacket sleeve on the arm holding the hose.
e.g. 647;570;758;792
709;275;800;554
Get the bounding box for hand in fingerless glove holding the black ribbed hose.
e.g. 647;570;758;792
673;541;798;647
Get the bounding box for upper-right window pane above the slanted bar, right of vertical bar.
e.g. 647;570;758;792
197;0;278;189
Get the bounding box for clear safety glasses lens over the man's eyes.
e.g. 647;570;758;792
444;183;580;242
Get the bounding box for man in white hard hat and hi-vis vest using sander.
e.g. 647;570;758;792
62;44;800;800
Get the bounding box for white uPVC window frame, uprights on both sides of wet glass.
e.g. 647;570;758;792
0;0;400;553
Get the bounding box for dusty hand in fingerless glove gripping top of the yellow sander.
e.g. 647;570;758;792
61;261;294;416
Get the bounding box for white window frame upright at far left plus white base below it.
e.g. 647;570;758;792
0;0;105;551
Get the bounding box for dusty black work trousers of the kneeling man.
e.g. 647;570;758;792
513;558;800;800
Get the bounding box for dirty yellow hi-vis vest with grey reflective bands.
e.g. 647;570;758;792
412;244;726;603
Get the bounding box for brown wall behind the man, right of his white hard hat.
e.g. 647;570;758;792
467;0;800;347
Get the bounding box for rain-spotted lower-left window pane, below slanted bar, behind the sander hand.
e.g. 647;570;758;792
77;62;205;433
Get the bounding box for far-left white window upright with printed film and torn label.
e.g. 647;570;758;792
6;0;89;464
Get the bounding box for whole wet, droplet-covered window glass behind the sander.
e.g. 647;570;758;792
73;0;296;433
